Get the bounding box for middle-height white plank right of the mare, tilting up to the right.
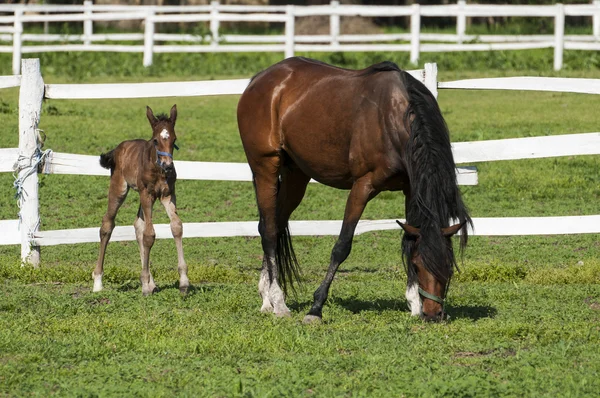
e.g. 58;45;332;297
452;133;600;163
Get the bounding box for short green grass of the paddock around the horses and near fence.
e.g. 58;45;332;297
0;56;600;397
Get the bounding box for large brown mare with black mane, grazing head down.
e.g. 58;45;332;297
238;58;471;322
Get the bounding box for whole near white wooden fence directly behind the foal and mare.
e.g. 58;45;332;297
0;59;600;265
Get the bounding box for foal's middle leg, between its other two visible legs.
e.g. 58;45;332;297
133;191;157;296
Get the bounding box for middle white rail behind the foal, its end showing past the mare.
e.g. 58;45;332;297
44;152;478;185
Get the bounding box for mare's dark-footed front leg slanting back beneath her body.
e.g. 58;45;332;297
304;178;377;323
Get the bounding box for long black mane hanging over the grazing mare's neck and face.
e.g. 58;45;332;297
398;71;472;282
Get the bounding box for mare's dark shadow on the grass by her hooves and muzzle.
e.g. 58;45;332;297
289;297;498;321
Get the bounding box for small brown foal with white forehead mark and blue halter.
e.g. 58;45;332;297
92;105;190;295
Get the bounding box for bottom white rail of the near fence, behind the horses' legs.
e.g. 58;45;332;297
34;215;600;246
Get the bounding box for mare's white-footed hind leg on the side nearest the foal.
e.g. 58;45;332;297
252;155;290;316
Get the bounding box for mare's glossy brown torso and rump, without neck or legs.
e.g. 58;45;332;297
238;58;408;188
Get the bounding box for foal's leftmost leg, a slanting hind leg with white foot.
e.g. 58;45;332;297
92;172;129;292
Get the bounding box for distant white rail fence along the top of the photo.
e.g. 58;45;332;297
0;0;600;74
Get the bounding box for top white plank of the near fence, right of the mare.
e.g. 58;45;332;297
438;77;600;94
